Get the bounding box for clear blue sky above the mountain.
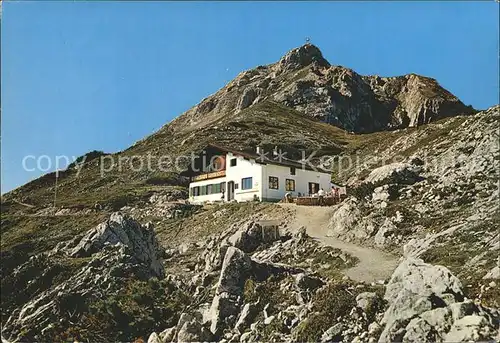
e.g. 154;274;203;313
1;1;499;193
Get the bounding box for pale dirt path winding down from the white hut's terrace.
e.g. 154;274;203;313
280;204;398;282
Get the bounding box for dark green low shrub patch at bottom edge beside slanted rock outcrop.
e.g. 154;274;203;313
51;278;190;342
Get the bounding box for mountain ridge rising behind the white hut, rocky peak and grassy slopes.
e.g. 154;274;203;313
0;44;482;207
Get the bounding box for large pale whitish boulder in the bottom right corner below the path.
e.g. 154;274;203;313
379;257;499;342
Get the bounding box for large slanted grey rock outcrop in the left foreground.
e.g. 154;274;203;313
2;213;163;340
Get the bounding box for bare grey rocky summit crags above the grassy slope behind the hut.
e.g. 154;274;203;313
170;44;474;132
